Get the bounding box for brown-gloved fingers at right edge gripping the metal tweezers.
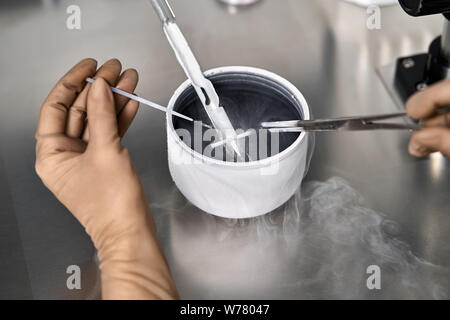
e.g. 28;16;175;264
406;81;450;157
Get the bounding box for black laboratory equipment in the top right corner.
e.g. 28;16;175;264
394;0;450;101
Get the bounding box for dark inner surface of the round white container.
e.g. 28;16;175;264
173;72;303;160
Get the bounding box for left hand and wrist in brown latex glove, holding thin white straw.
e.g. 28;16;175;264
36;59;177;299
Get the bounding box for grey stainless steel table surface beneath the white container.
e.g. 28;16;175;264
0;0;450;299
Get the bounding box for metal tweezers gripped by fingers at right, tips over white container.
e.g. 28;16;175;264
261;113;422;132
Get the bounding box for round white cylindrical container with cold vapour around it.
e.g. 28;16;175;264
167;67;310;219
